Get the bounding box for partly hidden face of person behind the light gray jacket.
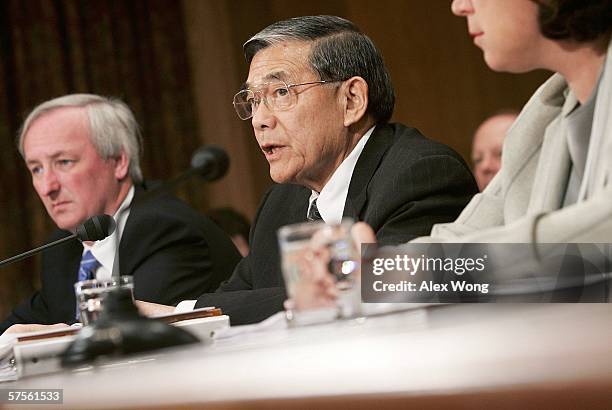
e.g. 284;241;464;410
472;110;518;191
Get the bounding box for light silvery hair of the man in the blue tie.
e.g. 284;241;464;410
17;94;142;183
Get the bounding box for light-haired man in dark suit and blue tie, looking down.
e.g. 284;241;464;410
0;94;240;333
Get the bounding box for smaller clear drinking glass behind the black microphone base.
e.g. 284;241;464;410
74;275;134;326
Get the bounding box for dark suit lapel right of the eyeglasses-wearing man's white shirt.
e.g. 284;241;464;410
342;125;394;220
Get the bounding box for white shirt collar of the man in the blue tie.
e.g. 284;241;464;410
83;185;134;279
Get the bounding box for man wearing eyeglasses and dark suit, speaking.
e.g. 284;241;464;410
141;16;477;325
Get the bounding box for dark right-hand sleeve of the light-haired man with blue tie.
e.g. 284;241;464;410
120;197;240;305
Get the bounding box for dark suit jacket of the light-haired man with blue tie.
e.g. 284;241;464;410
0;185;240;333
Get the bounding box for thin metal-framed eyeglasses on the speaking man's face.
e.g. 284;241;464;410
234;80;341;120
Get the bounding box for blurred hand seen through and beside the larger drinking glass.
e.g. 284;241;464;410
287;222;376;311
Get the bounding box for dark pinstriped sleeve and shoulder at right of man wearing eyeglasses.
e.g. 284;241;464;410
352;124;478;245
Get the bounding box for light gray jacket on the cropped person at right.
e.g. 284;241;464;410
417;43;612;247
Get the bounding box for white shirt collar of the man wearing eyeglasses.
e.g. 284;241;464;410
308;126;375;224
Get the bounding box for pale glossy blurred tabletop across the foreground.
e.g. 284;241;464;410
0;304;612;408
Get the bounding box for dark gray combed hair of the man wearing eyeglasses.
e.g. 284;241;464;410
243;16;395;124
